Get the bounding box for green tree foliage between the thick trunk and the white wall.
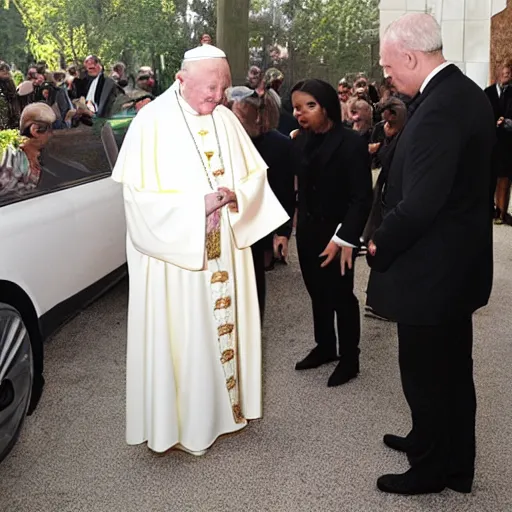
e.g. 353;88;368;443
251;0;379;90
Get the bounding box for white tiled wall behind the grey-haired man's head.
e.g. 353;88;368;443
380;0;507;87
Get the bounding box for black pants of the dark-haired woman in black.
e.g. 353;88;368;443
297;224;361;358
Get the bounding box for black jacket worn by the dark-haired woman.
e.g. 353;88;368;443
294;124;372;246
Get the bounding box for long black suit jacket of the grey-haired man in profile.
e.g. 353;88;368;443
368;65;495;325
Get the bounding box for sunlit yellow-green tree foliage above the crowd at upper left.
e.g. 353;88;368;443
5;0;186;79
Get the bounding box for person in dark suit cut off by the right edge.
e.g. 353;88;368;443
485;63;512;225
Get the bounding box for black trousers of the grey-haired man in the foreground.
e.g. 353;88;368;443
398;316;476;481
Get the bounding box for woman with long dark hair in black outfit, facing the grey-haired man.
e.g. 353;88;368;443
292;80;372;387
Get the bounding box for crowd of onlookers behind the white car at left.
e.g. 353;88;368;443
0;55;156;196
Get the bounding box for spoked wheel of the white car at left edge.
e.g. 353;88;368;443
0;303;34;462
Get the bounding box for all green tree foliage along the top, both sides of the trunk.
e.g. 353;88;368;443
0;0;379;89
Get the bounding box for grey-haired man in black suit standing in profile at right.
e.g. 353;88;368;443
368;14;495;494
